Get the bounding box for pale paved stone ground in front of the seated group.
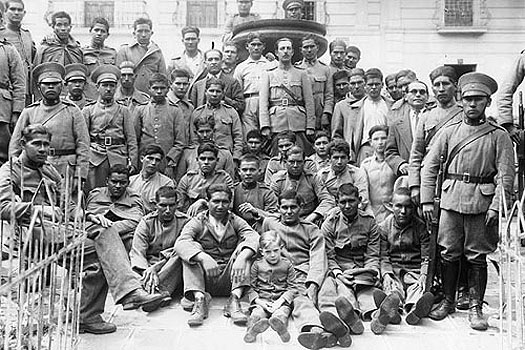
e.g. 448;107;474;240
79;267;508;350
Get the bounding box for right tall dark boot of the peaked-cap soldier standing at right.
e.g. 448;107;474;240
468;264;489;331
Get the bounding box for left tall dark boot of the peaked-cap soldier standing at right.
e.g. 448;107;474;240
428;260;460;321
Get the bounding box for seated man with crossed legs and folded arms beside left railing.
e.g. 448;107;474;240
80;164;162;334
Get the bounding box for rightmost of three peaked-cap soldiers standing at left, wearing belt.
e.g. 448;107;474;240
82;64;138;189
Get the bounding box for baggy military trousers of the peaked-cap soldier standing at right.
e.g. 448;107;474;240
437;209;499;264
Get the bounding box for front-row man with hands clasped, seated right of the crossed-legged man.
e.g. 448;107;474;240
129;186;188;307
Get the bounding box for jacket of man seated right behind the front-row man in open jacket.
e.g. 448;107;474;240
177;169;233;212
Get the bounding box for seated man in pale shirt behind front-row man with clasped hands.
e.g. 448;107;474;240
129;145;175;213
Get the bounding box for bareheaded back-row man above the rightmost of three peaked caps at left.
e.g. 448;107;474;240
82;17;117;100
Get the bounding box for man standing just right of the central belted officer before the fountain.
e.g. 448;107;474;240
295;34;334;130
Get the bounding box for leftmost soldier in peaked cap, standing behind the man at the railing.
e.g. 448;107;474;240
9;62;89;180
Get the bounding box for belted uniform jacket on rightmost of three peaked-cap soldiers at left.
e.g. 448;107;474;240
82;100;138;168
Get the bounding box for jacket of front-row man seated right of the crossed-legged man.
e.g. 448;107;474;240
129;211;189;270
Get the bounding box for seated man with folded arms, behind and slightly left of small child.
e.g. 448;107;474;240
233;154;277;232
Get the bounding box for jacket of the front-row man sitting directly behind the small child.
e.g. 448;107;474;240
262;217;327;287
